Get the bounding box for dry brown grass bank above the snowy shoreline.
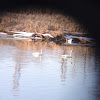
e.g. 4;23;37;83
0;9;85;36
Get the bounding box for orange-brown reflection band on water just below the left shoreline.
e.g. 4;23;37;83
0;39;61;51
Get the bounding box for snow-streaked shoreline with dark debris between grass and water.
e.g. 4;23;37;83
0;31;96;46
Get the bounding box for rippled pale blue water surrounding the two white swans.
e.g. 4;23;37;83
0;39;100;100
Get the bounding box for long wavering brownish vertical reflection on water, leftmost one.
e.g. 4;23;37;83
13;50;26;95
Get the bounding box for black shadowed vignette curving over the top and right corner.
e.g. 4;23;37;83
0;0;100;44
